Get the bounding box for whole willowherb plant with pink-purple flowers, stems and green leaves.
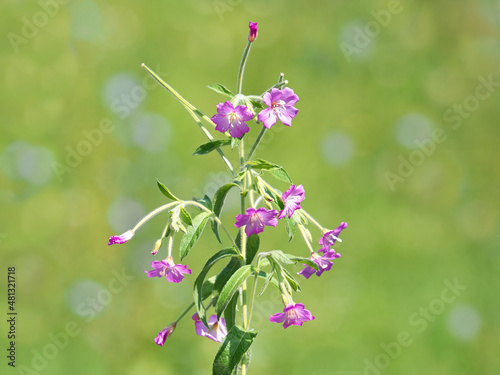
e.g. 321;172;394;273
108;22;347;375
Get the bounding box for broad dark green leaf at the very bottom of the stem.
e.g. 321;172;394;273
212;326;257;375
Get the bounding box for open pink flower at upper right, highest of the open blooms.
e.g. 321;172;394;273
258;87;299;129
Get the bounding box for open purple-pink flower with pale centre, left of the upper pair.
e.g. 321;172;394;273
212;101;253;138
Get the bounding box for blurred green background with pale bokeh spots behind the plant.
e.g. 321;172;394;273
0;0;500;375
